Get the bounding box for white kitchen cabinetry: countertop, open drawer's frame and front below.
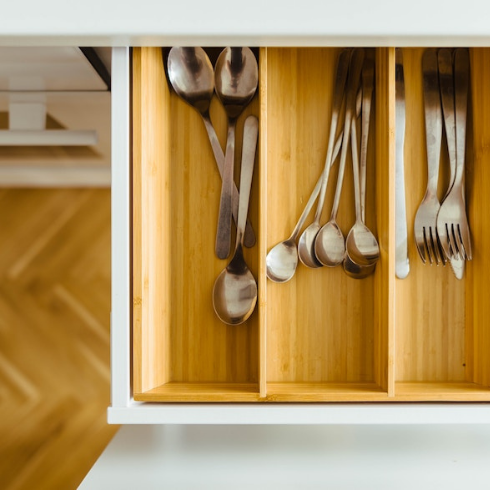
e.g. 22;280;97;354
0;0;490;490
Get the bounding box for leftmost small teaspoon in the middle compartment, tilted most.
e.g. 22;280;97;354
265;132;344;282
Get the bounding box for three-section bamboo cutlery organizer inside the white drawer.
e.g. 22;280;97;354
132;48;490;402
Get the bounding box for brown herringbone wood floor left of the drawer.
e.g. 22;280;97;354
0;189;117;490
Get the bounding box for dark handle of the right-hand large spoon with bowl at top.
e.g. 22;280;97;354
215;118;236;259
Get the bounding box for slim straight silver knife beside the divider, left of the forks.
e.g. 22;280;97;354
395;49;410;279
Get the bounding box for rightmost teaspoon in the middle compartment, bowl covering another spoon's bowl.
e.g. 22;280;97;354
346;58;379;266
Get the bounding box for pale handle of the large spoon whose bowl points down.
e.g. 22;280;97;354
236;116;259;248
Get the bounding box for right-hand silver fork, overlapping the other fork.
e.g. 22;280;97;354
437;49;472;260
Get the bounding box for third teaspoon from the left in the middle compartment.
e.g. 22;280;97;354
315;49;364;267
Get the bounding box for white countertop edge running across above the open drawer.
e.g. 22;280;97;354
0;0;490;46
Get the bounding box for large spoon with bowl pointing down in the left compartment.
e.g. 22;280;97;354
213;116;259;325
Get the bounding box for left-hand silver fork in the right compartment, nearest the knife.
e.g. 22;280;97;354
414;49;445;265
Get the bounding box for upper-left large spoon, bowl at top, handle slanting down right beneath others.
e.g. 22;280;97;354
167;47;256;247
